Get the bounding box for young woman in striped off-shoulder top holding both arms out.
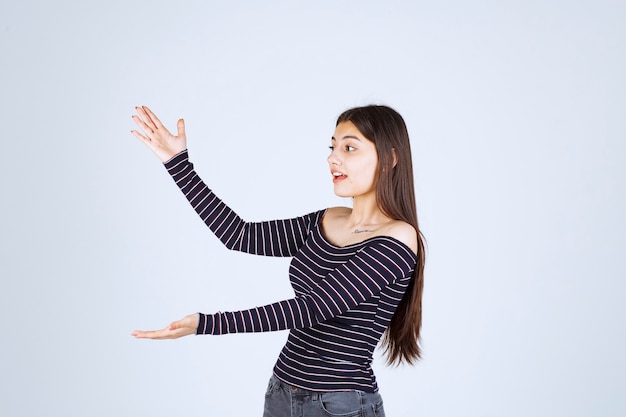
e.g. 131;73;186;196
132;106;424;417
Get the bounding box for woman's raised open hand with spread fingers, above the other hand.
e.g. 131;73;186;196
131;106;187;162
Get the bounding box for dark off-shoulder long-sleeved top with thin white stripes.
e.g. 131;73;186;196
165;151;416;392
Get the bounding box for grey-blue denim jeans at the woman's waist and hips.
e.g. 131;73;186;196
263;375;385;417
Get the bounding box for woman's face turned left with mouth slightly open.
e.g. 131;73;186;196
328;121;378;197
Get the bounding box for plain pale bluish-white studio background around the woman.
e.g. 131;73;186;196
0;0;626;417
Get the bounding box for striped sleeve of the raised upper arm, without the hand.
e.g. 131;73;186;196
164;150;323;256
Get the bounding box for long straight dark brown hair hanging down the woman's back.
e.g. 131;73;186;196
337;105;425;365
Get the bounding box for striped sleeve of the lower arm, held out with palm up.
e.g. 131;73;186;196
196;238;416;335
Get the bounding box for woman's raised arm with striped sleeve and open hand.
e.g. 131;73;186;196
132;107;312;256
